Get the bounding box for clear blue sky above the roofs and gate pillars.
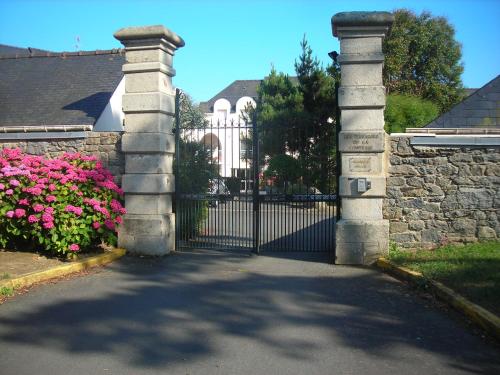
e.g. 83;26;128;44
0;0;500;101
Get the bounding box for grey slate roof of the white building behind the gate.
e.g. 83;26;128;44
200;77;298;113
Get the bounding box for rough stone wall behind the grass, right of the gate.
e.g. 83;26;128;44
383;135;500;248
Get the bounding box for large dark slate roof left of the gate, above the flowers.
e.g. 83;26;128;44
0;46;125;126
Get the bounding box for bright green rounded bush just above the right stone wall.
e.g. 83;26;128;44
384;94;439;133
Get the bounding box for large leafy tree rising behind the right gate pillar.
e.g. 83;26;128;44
383;9;464;113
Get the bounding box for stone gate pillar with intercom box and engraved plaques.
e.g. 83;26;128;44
332;12;394;264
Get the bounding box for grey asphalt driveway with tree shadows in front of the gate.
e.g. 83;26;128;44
0;251;500;375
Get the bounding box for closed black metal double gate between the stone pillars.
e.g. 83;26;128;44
174;90;336;255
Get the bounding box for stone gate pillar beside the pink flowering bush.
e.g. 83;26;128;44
114;25;184;255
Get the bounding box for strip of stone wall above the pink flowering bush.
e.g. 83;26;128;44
0;131;125;185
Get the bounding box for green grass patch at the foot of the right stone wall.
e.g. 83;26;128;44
389;241;500;315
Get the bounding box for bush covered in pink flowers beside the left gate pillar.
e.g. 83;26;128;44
0;149;125;255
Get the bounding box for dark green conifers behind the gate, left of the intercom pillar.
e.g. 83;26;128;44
256;37;339;191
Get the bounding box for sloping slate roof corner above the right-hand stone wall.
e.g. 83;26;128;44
424;75;500;128
